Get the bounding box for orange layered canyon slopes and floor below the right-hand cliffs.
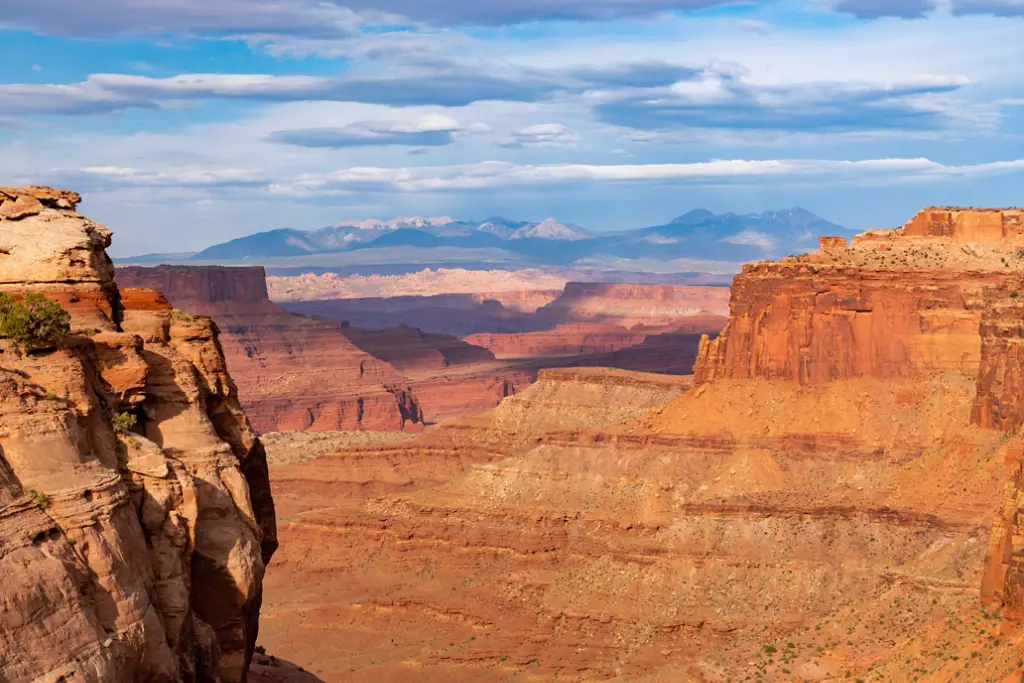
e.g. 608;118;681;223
249;370;1022;681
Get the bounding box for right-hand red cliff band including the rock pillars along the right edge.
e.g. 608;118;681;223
694;209;1024;620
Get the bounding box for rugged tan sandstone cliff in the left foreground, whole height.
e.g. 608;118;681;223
0;187;278;683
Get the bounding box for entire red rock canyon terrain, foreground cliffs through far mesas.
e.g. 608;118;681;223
8;192;1024;683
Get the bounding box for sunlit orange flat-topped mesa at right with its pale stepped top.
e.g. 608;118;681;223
694;208;1024;384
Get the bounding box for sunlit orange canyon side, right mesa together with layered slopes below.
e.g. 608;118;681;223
256;209;1024;682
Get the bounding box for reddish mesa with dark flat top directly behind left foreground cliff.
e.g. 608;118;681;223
117;266;421;432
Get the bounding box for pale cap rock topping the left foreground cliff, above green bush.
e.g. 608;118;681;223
0;185;121;331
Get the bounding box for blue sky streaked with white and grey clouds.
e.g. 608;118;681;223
0;0;1024;256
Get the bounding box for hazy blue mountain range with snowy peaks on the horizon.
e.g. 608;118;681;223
120;207;851;265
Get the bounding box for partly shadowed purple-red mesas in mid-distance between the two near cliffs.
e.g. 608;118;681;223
117;266;728;433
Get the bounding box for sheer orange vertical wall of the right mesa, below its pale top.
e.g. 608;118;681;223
694;263;1000;384
